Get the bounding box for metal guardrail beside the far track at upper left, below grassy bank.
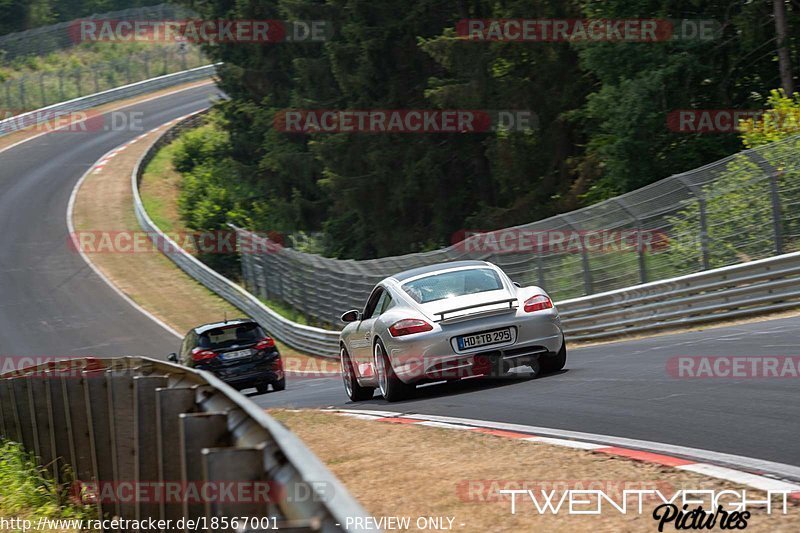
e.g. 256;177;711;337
0;65;217;137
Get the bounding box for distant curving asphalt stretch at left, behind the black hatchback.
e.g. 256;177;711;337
0;85;218;358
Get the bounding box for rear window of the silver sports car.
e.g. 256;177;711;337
401;268;503;304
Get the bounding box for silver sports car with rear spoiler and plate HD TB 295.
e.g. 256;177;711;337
340;261;567;402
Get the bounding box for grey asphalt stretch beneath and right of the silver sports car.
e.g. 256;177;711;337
253;304;800;465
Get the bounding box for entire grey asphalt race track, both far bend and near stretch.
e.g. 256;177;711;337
0;88;800;465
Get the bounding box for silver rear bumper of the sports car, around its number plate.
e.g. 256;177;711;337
386;310;564;383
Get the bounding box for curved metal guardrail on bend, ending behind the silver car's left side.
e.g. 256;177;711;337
131;114;339;357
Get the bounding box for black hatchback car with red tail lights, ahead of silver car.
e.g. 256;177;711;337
169;319;286;394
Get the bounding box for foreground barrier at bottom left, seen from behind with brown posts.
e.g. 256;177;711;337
0;357;376;532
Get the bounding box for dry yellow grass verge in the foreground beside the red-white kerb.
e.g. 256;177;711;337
270;410;800;532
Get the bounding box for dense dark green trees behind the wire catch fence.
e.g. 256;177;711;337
166;0;797;262
